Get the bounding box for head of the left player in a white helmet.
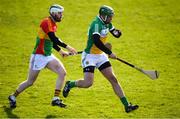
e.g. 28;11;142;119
49;4;64;22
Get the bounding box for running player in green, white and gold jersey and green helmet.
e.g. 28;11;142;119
63;5;138;113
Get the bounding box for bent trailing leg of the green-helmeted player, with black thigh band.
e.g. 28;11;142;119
63;66;95;97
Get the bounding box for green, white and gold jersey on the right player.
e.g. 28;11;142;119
85;16;114;54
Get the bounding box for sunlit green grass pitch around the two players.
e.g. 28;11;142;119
0;0;180;118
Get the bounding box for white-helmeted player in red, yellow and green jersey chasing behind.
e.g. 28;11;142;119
8;4;77;108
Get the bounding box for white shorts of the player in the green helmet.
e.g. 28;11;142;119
81;52;109;68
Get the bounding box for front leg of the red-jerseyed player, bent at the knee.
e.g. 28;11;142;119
46;58;66;107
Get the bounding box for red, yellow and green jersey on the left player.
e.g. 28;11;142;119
33;17;57;56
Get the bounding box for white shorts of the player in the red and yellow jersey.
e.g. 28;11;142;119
30;54;57;70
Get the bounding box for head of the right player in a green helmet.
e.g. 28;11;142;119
99;5;114;23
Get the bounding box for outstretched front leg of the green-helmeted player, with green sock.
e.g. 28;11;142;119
99;62;138;113
